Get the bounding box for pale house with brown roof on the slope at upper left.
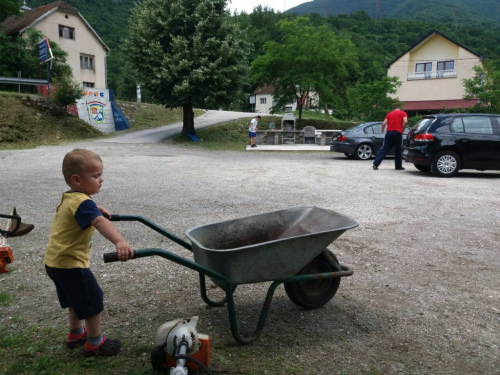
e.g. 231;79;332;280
2;1;110;89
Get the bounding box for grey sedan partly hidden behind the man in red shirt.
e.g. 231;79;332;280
330;122;409;160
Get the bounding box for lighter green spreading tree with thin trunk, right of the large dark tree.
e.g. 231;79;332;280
252;17;357;119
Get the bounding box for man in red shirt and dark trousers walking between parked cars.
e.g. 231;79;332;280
373;108;408;171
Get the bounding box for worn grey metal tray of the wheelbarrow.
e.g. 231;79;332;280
186;206;358;286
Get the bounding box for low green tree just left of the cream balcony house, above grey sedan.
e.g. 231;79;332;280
347;77;401;121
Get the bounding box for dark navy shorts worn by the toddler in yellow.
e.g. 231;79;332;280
45;265;104;320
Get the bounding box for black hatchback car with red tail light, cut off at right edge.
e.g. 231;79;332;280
403;113;500;177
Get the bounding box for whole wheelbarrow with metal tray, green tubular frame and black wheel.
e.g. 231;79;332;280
104;206;358;344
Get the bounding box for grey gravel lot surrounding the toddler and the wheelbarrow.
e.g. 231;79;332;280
0;142;500;374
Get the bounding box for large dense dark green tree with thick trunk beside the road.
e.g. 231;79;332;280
125;0;250;137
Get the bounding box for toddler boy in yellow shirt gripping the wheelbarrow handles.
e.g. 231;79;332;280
44;148;133;356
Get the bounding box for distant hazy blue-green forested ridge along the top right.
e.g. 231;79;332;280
286;0;500;24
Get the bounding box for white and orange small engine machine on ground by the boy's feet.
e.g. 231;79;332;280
151;316;210;375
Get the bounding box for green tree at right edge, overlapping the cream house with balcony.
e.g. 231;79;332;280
463;62;500;113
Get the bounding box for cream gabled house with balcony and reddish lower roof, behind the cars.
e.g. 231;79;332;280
387;30;485;114
